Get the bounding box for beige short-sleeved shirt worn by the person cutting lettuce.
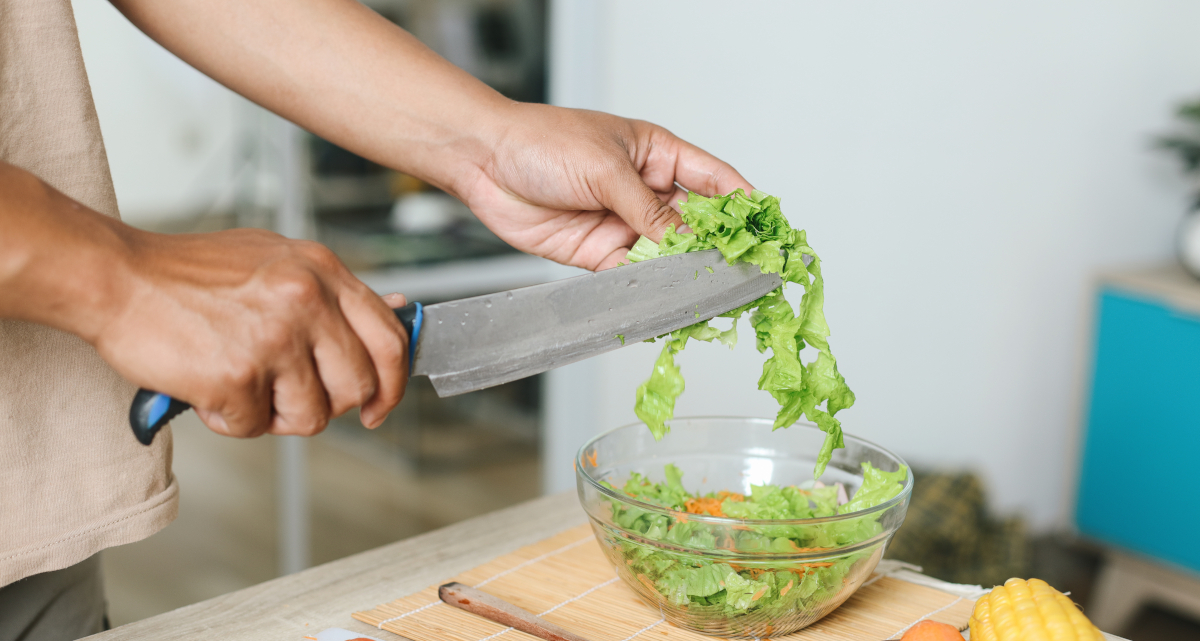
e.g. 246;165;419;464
0;0;179;586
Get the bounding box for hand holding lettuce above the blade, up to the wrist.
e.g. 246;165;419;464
454;103;751;270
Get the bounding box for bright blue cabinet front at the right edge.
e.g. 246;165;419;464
1075;284;1200;571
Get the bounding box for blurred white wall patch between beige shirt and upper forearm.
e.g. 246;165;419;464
73;0;243;224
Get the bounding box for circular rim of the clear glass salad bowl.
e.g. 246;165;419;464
575;417;913;526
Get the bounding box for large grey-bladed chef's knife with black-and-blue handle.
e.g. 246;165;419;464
130;250;787;445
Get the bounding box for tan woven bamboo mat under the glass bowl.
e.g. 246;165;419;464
354;526;974;641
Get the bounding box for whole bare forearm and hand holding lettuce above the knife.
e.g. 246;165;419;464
112;0;752;269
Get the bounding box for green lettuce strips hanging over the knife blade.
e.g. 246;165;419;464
626;190;854;478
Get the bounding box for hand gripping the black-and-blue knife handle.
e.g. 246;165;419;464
86;229;408;437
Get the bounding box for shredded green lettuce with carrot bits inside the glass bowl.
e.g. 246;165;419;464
604;463;907;621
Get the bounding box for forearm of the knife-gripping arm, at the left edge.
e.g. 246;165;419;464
0;162;131;340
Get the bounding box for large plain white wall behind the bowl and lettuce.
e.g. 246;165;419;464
547;0;1200;527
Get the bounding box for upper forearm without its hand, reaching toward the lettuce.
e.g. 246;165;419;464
113;0;510;194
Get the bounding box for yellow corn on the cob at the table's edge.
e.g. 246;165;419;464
970;579;1104;641
